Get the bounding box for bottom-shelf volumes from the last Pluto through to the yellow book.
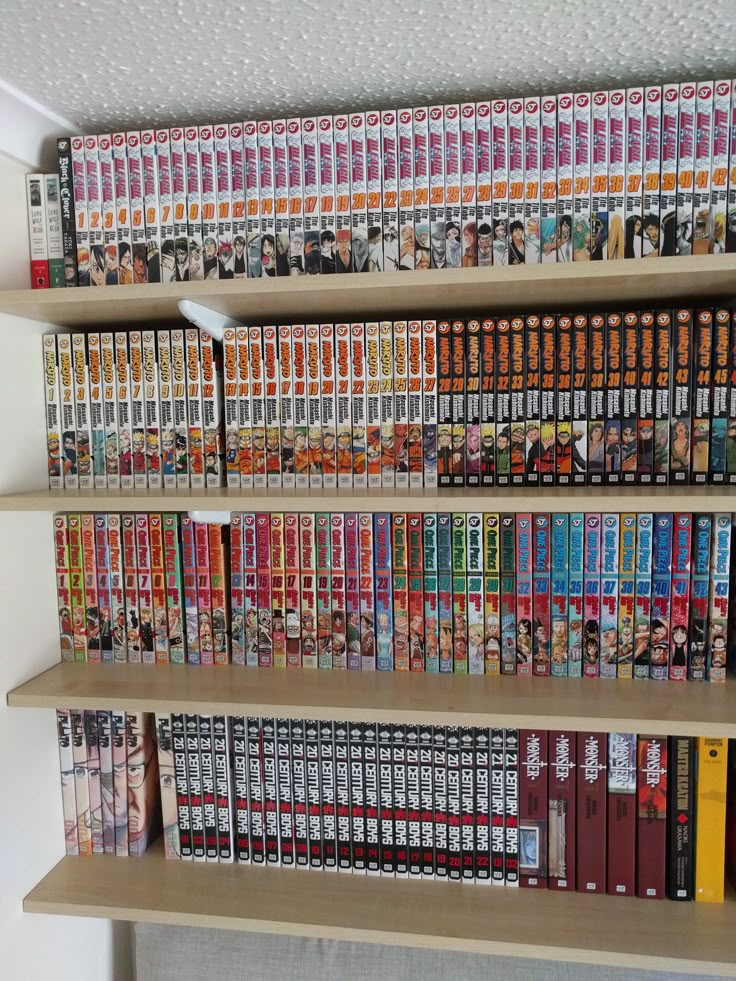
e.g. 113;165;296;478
151;715;727;902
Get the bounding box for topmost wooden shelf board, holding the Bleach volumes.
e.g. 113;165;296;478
0;255;736;329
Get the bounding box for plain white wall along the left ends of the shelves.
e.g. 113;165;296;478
0;149;131;981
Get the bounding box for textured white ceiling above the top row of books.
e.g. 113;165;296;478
0;0;736;132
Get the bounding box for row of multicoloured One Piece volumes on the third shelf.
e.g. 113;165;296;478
54;512;736;682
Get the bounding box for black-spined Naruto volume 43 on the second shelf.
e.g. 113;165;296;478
670;310;692;484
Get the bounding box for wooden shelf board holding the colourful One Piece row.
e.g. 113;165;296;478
7;663;736;738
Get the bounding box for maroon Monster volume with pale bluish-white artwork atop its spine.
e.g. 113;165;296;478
606;732;636;896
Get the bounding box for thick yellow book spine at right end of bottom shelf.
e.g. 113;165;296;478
695;736;728;903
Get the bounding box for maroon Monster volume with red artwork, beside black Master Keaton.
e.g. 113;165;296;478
636;736;667;899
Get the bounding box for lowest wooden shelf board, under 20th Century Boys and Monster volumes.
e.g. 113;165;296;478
23;843;736;977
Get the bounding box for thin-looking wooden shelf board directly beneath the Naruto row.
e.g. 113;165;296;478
0;486;736;512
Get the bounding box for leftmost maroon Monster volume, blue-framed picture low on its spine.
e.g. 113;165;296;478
519;729;549;889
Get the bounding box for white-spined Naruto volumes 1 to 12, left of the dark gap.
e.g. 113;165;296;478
43;328;225;490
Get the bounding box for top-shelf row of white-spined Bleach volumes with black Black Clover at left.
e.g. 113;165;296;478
36;79;736;286
